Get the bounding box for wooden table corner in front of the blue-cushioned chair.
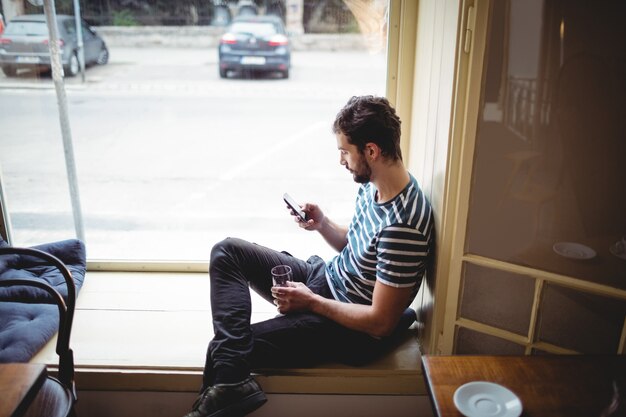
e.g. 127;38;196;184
0;363;47;417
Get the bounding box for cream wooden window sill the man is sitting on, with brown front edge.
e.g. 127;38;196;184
32;272;426;395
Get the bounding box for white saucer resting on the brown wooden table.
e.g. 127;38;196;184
453;381;522;417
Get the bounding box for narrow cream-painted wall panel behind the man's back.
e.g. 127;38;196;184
409;0;460;352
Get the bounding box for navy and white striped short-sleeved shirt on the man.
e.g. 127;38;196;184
326;175;433;304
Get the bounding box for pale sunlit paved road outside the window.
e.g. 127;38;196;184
0;49;384;259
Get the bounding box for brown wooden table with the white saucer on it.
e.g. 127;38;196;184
422;355;626;417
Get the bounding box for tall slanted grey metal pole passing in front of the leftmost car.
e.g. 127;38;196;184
43;0;85;241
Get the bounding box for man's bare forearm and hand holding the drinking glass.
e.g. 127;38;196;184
272;282;413;337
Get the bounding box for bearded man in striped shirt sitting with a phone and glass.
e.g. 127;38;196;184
186;96;433;417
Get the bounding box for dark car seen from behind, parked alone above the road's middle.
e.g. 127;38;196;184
218;16;291;78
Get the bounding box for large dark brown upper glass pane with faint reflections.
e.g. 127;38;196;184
466;0;626;288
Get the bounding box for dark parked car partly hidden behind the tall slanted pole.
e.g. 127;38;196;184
0;14;109;76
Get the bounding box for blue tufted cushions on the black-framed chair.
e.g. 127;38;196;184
0;239;86;363
